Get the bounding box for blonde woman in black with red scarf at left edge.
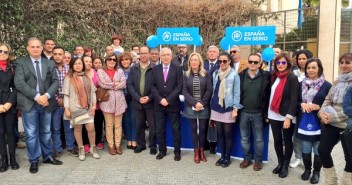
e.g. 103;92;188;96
0;43;20;172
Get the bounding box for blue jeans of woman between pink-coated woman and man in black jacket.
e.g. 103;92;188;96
122;100;137;141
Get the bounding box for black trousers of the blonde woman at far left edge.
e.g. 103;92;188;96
0;112;17;155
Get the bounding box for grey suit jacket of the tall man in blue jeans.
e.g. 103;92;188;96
15;56;59;112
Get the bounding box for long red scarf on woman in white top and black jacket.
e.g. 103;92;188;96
270;70;289;113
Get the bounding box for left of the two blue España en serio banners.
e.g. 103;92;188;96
157;27;200;45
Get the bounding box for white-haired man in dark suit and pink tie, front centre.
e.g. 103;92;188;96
151;48;183;161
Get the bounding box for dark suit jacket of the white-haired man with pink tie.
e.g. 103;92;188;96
151;62;183;112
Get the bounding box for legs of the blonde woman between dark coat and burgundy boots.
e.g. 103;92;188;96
189;119;208;148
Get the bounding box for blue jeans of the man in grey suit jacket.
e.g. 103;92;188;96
22;103;52;163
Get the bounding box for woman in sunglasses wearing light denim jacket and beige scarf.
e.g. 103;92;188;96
210;53;242;168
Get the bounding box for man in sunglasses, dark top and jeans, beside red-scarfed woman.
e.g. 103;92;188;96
239;53;270;171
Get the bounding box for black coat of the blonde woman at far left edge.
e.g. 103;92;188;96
0;65;17;113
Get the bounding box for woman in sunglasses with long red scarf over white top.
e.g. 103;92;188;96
268;53;299;178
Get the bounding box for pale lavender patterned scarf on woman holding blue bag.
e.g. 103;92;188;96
302;75;325;103
